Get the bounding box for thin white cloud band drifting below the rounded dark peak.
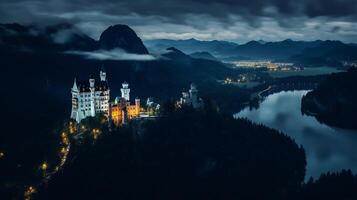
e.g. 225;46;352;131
65;49;156;61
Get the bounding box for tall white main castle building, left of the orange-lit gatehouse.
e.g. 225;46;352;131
71;70;108;122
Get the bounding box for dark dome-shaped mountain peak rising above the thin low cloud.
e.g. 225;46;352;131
99;24;149;54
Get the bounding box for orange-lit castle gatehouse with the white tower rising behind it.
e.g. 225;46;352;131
110;82;141;126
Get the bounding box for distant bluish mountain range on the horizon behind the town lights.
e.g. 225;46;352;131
144;39;357;66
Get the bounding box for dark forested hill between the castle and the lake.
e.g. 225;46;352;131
37;103;306;199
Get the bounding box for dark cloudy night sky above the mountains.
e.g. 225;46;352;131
0;0;357;43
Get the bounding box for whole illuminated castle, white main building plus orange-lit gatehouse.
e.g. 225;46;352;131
71;70;141;126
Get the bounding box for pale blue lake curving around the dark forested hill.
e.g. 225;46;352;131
234;91;357;180
